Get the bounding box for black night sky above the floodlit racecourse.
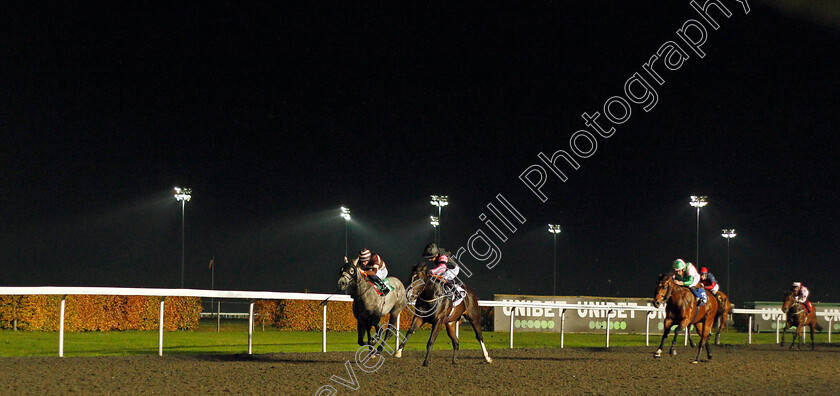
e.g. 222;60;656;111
0;0;840;304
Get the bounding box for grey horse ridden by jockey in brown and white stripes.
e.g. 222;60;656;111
338;259;405;351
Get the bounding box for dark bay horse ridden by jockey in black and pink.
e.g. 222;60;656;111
394;262;493;366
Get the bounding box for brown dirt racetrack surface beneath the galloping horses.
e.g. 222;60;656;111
0;345;840;395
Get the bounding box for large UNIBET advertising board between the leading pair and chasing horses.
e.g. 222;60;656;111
493;294;665;333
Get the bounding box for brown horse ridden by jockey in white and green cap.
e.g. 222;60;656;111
653;273;718;363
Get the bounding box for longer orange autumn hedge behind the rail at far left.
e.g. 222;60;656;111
0;295;201;331
